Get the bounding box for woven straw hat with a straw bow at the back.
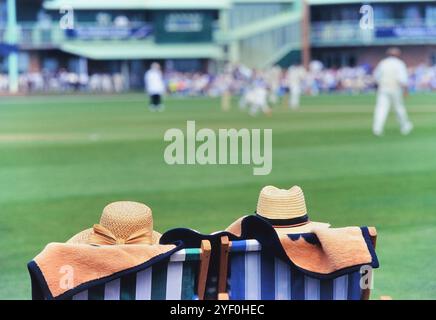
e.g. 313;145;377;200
67;201;161;245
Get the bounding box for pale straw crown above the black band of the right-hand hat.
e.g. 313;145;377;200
257;186;307;219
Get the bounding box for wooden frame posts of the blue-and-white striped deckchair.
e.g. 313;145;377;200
218;227;377;300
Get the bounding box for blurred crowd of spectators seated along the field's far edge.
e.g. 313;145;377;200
0;61;436;96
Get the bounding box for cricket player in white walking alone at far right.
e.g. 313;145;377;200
373;48;413;136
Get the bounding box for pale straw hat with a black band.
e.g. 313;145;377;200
256;186;330;235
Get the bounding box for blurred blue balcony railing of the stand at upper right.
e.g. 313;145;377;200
311;20;436;46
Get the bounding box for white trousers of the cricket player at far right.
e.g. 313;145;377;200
373;90;412;135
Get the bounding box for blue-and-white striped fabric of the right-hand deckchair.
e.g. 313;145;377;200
229;240;361;300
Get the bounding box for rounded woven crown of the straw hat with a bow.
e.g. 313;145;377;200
100;201;153;239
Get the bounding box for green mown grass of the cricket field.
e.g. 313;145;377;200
0;94;436;299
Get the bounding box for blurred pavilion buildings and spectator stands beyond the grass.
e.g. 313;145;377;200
0;0;436;94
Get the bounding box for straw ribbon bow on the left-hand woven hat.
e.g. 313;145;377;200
89;224;151;245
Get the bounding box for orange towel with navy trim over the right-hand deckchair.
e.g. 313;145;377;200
226;216;378;275
